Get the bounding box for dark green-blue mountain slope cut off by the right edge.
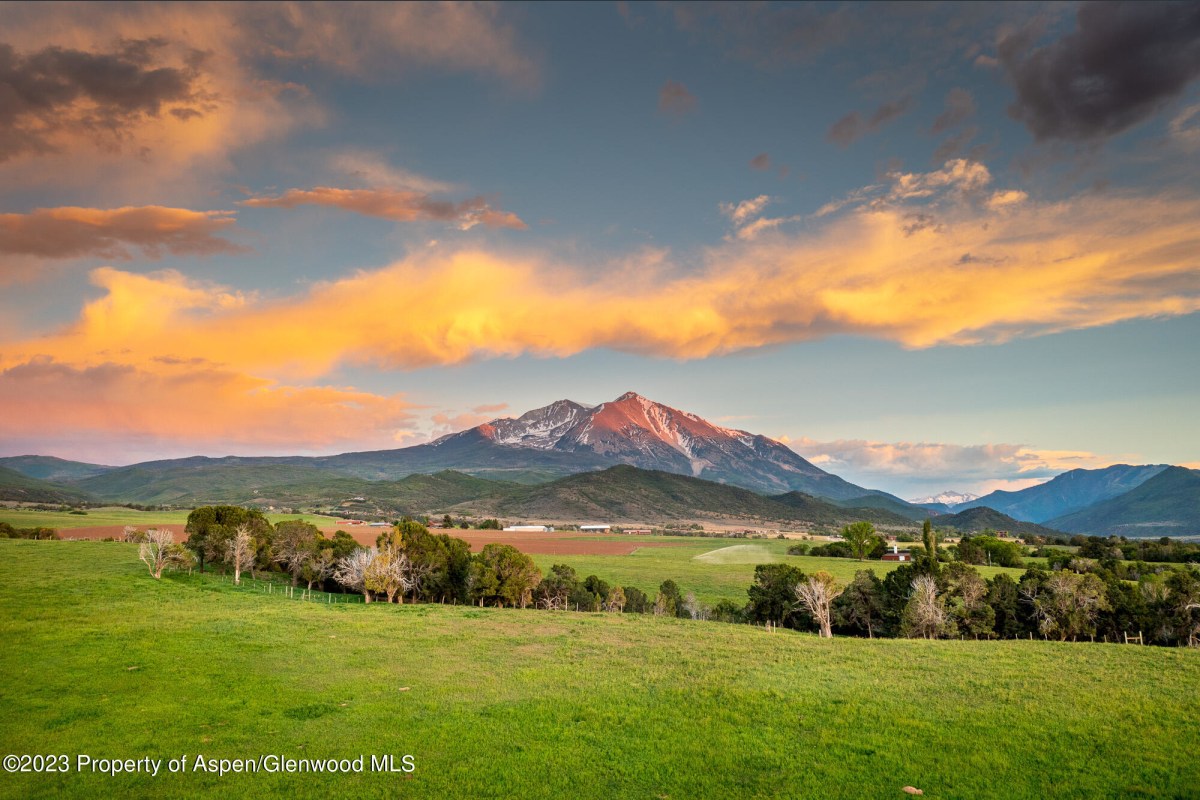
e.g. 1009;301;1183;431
1048;467;1200;539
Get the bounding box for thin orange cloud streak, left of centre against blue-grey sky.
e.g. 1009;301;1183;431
241;186;528;230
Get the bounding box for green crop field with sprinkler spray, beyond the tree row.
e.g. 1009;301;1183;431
532;536;1024;604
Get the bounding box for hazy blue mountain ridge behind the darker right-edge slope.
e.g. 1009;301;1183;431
958;464;1168;522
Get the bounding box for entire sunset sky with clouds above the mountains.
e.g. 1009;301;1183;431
0;2;1200;498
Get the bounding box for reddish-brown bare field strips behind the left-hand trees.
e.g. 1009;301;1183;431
59;524;688;555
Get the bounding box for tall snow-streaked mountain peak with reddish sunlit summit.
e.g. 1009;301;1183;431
427;392;904;504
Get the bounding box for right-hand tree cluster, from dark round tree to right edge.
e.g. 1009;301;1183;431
743;522;1200;646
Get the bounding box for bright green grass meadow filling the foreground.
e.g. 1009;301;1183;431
0;541;1200;800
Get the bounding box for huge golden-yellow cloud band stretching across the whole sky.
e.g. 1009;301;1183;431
7;170;1200;380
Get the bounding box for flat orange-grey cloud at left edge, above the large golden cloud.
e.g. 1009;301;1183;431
0;205;244;262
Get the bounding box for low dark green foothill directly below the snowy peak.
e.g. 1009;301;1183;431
451;465;912;527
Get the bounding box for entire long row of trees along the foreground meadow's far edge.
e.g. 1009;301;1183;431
129;506;1200;646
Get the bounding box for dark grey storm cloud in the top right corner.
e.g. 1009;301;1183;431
998;2;1200;142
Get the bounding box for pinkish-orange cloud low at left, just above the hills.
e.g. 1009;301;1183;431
0;359;415;453
